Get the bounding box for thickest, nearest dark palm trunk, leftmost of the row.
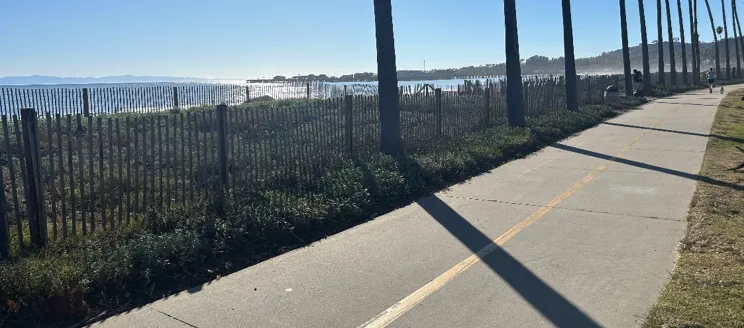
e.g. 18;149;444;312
374;0;403;154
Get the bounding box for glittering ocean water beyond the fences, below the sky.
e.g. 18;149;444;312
0;78;506;115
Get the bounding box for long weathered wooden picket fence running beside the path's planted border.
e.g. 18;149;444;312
0;72;644;258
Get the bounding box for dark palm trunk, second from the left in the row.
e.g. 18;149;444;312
502;0;525;126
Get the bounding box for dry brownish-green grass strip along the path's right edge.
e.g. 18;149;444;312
644;89;744;328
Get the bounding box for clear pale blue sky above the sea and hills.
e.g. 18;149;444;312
0;0;732;79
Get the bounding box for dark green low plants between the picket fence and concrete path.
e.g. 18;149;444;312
0;99;640;326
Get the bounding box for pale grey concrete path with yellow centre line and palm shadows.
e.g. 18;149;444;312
93;86;735;328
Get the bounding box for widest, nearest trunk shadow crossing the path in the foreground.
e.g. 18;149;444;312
417;195;601;327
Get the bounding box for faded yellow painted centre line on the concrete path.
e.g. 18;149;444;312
359;107;679;328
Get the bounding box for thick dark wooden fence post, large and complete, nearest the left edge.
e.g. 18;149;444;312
21;108;48;247
